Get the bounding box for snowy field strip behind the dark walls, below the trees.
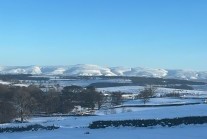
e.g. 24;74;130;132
0;104;207;128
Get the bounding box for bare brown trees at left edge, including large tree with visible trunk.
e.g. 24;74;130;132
0;85;42;123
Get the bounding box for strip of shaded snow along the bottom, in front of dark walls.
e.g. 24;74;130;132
0;125;207;139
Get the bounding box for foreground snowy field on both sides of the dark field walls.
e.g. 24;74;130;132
0;104;207;139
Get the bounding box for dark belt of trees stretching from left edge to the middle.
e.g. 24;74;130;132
0;85;103;123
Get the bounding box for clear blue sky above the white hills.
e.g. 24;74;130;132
0;0;207;71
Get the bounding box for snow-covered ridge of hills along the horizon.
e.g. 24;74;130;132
0;64;207;80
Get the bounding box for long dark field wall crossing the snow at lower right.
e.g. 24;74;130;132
89;116;207;129
